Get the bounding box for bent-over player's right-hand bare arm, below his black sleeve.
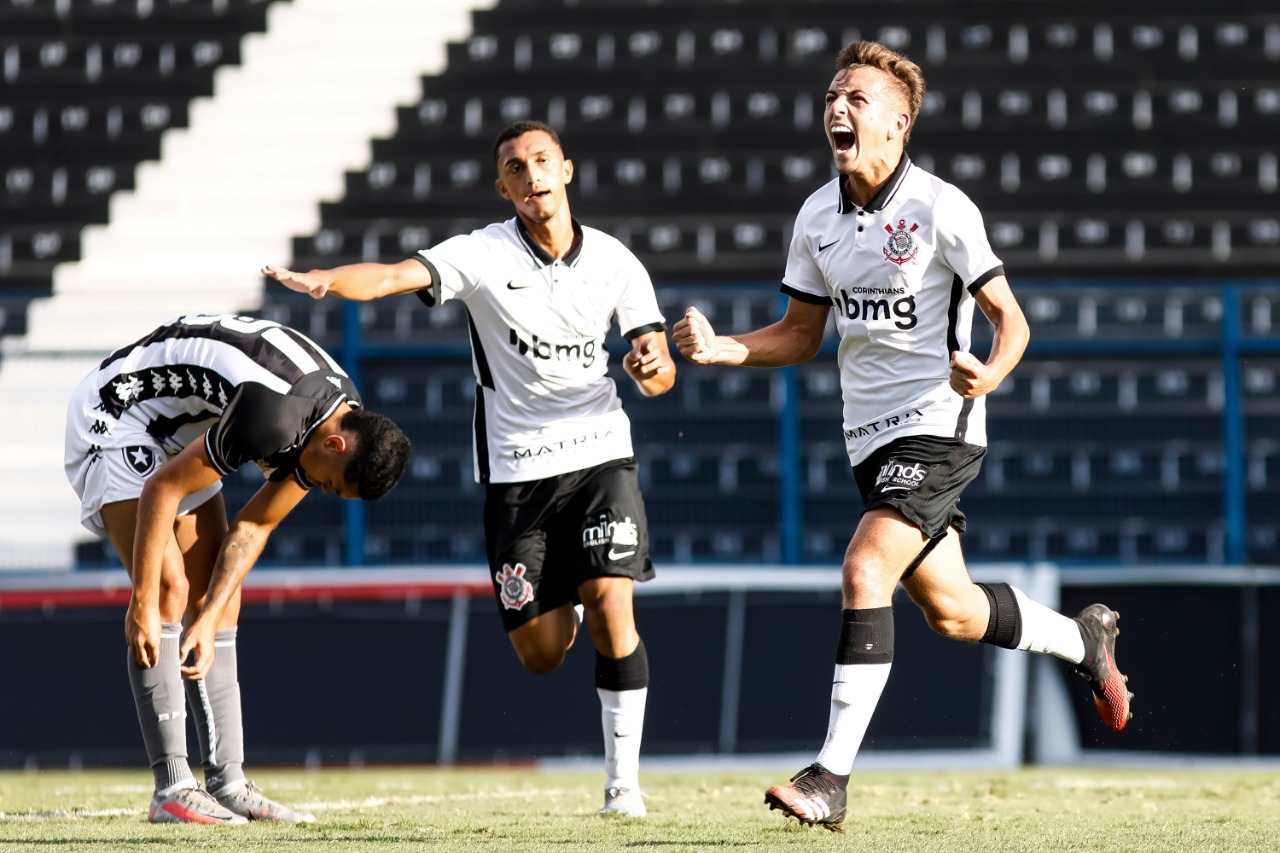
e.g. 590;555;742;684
179;480;307;679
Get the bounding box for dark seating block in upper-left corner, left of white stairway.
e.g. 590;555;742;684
0;0;282;300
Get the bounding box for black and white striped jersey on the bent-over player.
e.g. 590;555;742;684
96;314;360;488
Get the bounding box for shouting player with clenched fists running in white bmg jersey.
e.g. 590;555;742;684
672;42;1130;829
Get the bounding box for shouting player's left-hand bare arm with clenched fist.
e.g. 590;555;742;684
672;300;831;368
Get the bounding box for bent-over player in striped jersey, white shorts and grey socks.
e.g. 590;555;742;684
65;314;410;824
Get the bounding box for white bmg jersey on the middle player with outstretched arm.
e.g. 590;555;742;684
416;218;664;483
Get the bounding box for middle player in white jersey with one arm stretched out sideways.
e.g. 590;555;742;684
264;122;676;817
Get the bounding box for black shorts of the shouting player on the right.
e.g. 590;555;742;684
854;435;987;539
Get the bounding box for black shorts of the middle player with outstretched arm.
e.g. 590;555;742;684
484;459;654;631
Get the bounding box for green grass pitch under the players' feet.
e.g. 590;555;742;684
0;767;1280;853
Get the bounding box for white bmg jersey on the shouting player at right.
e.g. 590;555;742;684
782;154;1004;465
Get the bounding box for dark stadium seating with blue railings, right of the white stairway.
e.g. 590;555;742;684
0;0;1280;564
